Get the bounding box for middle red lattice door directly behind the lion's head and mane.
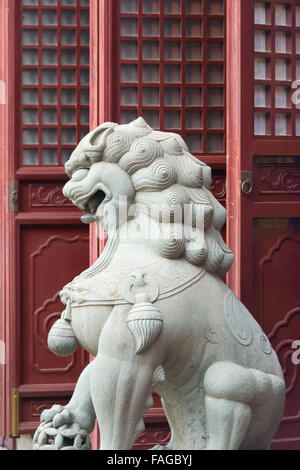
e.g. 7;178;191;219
91;0;226;449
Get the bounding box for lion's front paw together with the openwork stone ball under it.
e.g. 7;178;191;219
33;405;92;450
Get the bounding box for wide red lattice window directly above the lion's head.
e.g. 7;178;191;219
119;0;225;155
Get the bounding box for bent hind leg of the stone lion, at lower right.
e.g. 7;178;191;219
204;362;284;450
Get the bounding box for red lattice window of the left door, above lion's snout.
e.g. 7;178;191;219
20;0;89;166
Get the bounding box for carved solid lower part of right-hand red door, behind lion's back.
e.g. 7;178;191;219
250;160;300;449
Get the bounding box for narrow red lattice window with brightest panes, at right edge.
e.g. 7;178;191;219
254;0;300;138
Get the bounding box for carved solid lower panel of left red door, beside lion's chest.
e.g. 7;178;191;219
18;220;89;433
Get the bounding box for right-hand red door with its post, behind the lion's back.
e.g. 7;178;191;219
227;0;300;449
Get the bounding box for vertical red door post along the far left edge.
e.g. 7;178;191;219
0;0;19;445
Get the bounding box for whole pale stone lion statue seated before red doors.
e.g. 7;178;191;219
34;118;285;450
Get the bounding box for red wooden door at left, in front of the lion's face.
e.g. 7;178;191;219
0;0;89;437
